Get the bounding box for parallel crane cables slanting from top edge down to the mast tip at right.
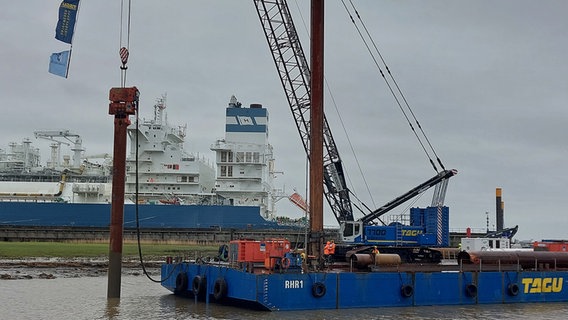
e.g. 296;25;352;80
341;0;445;172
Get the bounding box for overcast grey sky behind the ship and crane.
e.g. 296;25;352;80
0;0;568;239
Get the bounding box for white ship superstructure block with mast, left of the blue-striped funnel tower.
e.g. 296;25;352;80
125;96;216;204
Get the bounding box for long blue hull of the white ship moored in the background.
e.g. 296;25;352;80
0;202;278;229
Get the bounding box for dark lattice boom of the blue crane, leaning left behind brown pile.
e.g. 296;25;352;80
253;0;353;223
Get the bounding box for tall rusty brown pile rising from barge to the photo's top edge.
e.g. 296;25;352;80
308;0;324;257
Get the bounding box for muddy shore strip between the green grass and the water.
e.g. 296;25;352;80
0;257;164;280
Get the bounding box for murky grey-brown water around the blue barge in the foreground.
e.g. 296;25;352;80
0;275;568;320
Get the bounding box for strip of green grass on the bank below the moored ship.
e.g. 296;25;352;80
0;242;218;259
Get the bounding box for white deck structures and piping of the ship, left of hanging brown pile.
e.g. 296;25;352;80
0;135;111;203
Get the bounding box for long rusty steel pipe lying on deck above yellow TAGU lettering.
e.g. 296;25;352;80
458;250;568;269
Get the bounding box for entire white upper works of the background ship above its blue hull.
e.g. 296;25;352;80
0;96;277;225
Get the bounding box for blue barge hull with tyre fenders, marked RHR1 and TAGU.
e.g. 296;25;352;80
161;262;568;311
